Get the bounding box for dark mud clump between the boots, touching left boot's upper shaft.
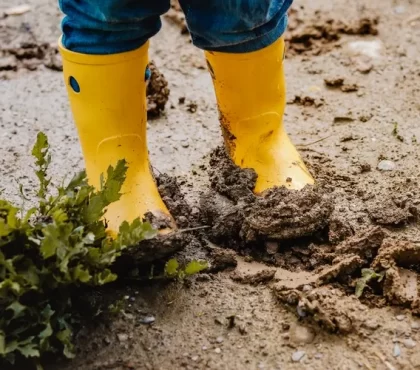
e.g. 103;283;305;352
146;61;170;118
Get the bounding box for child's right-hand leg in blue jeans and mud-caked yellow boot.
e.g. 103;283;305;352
181;0;313;193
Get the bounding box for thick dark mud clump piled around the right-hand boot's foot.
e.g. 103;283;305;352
201;148;333;245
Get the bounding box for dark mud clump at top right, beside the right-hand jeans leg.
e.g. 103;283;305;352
285;9;379;55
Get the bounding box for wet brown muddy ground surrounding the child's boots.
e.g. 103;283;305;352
0;0;420;370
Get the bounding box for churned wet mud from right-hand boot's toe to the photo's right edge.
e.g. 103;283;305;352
194;148;420;333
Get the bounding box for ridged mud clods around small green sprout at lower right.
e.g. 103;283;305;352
273;227;420;333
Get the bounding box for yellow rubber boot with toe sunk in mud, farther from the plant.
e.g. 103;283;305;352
206;38;314;193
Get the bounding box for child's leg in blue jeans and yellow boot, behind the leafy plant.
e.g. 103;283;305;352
60;0;175;233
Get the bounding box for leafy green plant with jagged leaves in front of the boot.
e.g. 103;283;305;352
0;133;156;367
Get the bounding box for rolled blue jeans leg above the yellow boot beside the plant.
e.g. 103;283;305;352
59;0;169;54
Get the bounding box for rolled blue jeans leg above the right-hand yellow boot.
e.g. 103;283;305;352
180;0;292;53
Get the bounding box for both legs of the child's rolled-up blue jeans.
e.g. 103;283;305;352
59;0;293;54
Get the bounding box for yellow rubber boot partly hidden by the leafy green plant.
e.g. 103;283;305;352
60;42;174;235
